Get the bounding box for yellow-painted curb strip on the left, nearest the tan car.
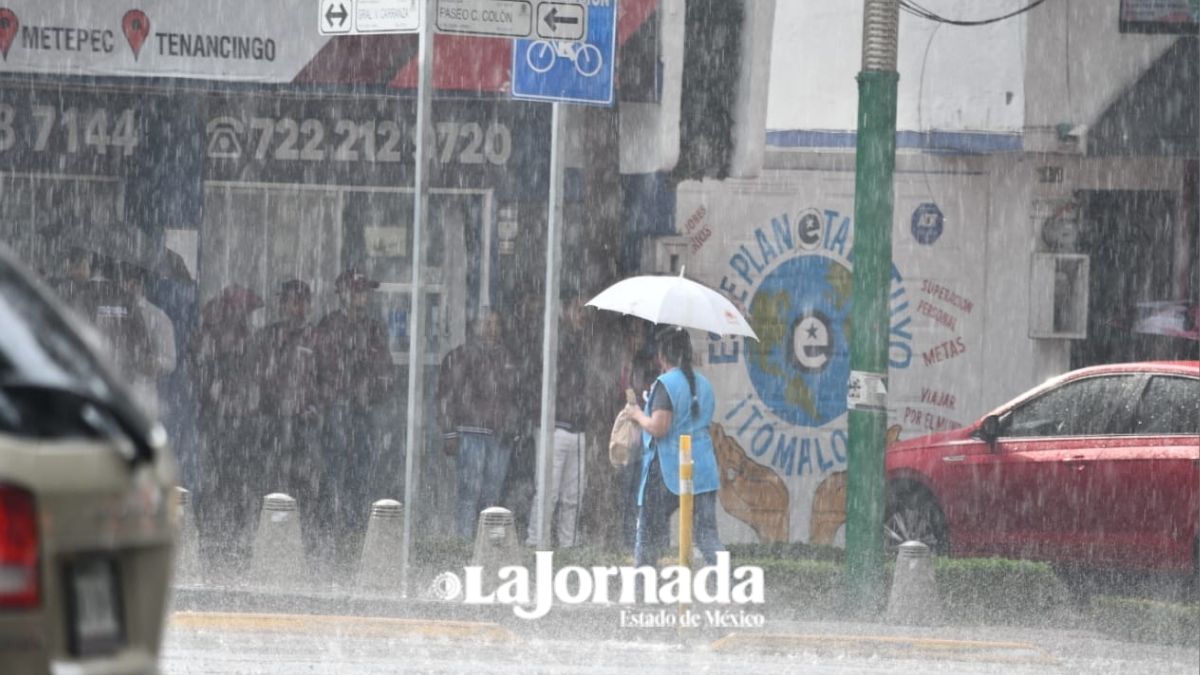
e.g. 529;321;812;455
169;611;517;644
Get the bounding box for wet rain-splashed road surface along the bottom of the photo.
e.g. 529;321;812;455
162;615;1200;675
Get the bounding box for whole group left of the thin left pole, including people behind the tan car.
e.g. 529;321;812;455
52;250;395;578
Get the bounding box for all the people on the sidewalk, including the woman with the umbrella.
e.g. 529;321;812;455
54;247;720;578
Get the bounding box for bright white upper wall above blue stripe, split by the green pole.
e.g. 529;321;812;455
767;0;1027;132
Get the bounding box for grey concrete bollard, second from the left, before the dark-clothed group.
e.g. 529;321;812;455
248;492;310;589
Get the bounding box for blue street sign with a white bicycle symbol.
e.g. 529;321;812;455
512;0;617;106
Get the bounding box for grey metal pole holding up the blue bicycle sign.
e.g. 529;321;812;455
532;102;566;549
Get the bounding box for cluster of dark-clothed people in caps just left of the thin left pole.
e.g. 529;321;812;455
188;269;394;566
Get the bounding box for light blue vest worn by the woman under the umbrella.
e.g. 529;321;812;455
637;368;720;506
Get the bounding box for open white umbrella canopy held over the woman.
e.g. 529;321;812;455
588;274;758;340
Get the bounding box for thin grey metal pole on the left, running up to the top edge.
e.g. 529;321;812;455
401;0;437;597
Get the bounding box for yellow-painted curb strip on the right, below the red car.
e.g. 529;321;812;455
709;633;1057;664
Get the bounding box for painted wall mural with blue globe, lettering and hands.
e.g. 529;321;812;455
677;176;982;545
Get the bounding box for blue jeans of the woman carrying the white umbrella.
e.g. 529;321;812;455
634;458;725;567
